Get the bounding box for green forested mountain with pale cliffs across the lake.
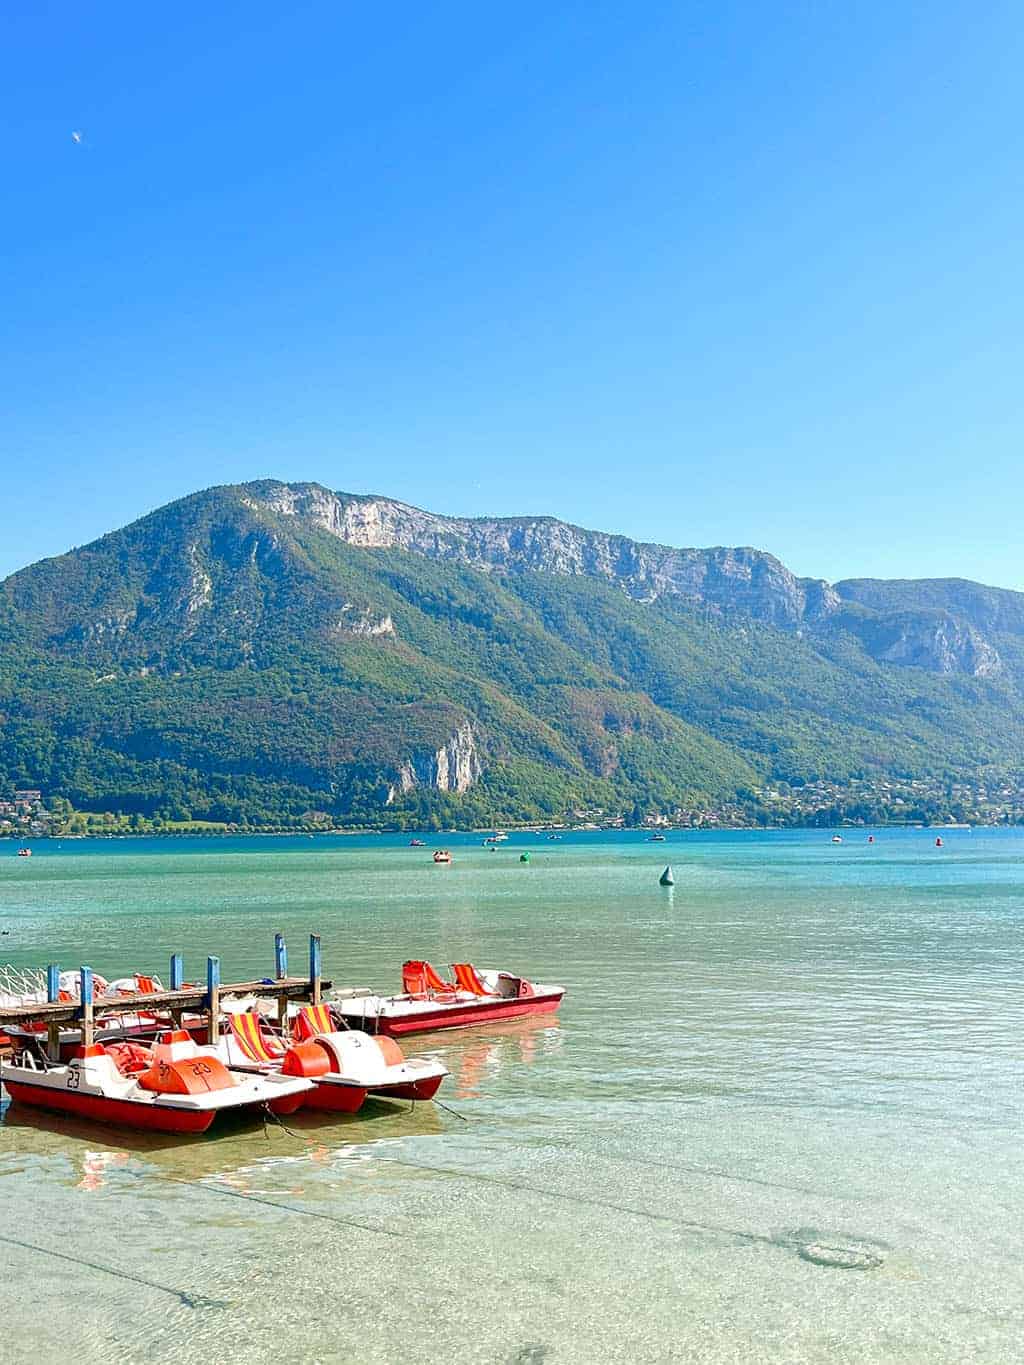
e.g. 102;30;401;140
0;480;1024;824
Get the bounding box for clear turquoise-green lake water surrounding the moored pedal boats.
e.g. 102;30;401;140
0;830;1024;1365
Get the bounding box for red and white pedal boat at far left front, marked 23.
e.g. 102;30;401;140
0;1029;313;1133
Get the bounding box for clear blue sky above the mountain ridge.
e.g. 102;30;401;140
0;0;1024;588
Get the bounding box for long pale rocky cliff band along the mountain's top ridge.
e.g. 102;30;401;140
244;483;1024;677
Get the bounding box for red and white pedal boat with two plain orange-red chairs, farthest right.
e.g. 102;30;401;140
330;961;565;1036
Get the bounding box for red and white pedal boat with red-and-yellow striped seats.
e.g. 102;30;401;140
218;1005;448;1114
